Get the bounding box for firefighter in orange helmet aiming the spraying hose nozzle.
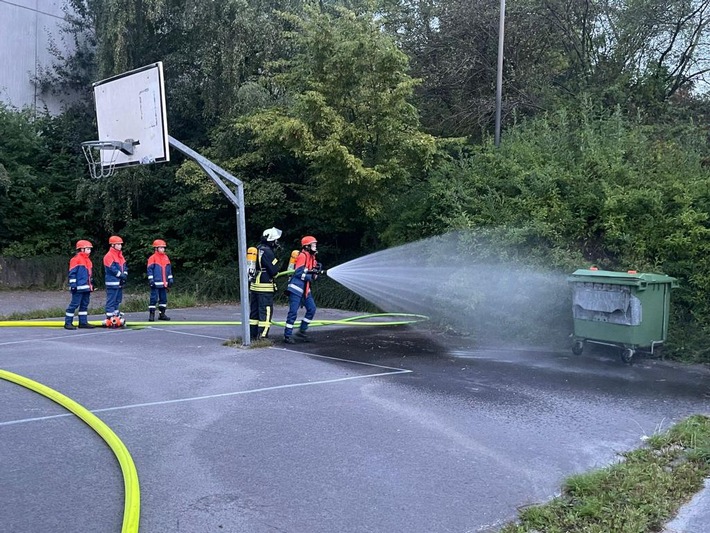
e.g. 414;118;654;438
284;235;322;344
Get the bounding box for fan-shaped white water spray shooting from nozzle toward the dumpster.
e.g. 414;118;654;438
328;233;572;346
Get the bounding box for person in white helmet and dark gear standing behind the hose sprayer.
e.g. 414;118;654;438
249;228;281;339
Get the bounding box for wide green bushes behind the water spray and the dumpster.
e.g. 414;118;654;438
388;104;710;362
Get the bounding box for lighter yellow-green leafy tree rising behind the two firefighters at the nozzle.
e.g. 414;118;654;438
238;2;436;235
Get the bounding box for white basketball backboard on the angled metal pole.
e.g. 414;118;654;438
85;62;170;168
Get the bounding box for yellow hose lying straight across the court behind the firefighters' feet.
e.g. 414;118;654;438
0;313;429;328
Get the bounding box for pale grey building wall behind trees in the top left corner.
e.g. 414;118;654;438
0;0;73;114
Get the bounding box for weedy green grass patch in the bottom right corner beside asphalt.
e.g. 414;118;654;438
501;415;710;533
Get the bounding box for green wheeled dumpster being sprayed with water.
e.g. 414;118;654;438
568;269;678;364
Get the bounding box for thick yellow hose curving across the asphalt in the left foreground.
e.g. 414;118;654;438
0;369;141;533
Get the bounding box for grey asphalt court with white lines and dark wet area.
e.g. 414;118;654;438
0;307;710;533
